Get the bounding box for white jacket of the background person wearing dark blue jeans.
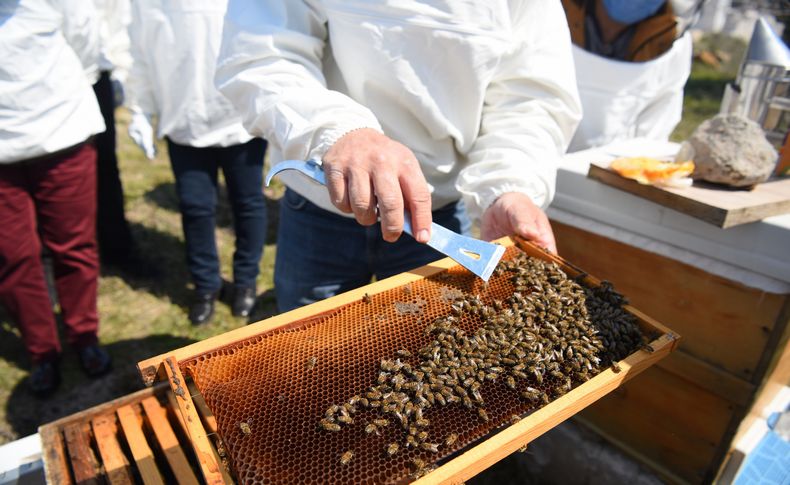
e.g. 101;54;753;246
125;0;252;158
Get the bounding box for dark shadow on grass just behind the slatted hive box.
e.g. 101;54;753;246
2;334;195;437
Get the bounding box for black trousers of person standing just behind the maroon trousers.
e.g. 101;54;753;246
93;71;132;263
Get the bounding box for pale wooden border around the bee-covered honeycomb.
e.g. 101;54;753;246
137;237;680;485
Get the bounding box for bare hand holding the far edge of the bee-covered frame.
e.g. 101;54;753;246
480;192;557;254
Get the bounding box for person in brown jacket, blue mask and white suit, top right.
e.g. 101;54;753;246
562;0;702;151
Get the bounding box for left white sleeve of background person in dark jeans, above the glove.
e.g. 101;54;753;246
124;2;159;120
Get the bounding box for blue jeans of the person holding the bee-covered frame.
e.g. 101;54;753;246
274;190;471;312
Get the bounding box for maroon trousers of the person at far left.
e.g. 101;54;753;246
0;143;99;362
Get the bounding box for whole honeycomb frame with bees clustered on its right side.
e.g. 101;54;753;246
139;239;678;483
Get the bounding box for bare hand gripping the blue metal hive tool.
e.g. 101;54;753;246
323;128;431;243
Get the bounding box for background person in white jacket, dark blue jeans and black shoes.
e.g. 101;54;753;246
126;0;266;325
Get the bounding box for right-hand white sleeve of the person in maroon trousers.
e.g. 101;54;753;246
55;0;100;84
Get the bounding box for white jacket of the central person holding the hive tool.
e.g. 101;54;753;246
216;0;580;217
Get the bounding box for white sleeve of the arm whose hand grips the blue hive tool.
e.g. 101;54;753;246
215;0;381;160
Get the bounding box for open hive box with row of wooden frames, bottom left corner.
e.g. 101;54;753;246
39;384;209;485
